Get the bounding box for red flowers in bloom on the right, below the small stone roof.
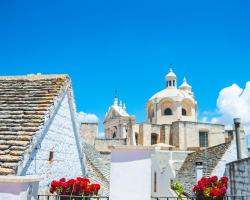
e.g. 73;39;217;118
193;176;228;200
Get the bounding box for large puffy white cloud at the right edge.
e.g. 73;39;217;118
202;81;250;132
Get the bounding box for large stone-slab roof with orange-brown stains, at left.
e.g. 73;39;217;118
0;75;68;175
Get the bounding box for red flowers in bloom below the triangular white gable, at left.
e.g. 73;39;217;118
50;177;101;200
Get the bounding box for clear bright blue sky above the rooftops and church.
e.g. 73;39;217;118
0;0;250;130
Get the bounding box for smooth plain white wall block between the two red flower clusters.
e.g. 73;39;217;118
110;149;151;200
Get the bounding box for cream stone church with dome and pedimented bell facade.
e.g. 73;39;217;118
104;69;230;150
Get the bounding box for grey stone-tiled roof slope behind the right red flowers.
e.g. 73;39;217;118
175;142;231;194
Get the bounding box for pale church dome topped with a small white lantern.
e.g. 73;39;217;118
147;70;197;124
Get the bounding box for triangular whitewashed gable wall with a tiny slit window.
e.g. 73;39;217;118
22;93;84;189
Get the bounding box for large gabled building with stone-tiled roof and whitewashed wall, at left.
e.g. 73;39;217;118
0;75;85;190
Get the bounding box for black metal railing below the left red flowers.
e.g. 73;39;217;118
37;195;109;200
